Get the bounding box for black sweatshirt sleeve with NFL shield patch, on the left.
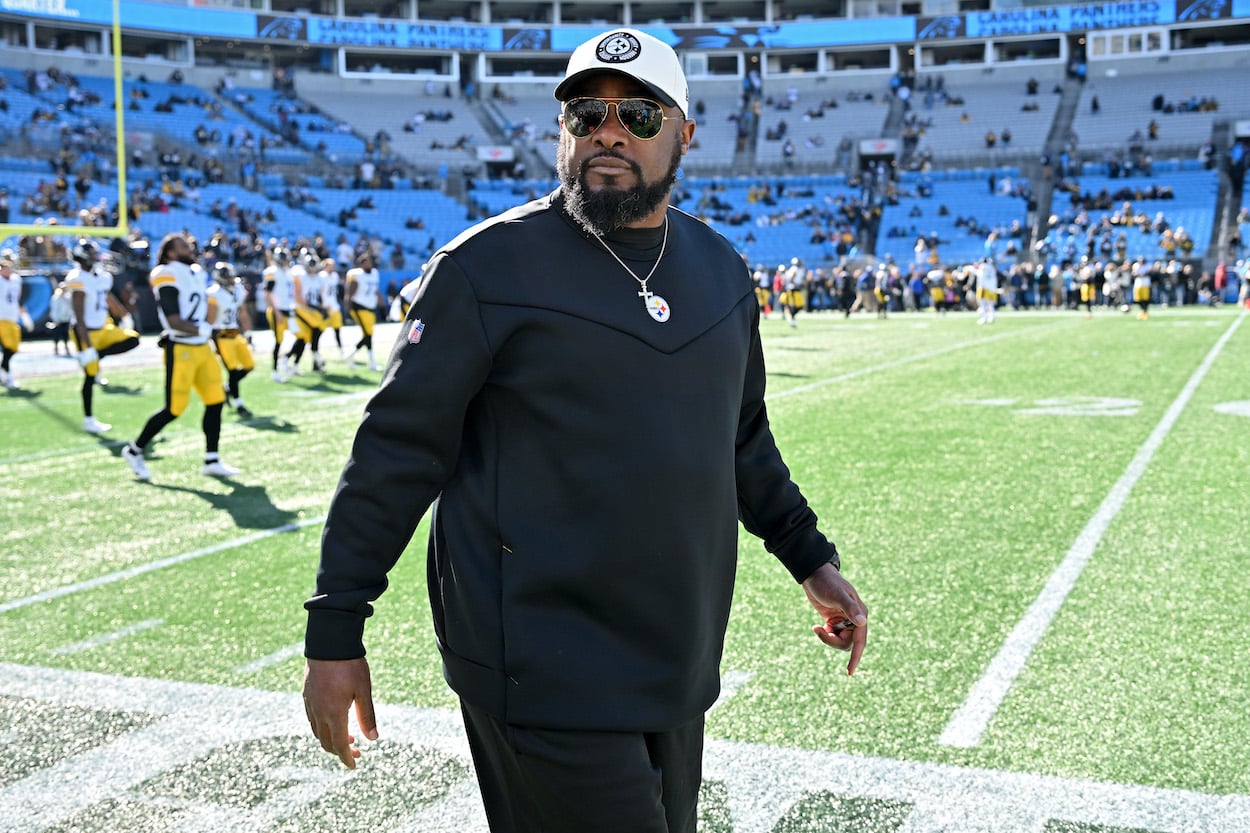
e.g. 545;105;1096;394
304;255;491;659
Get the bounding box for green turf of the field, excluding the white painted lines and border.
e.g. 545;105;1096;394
0;310;1250;800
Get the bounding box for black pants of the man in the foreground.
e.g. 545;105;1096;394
461;700;704;833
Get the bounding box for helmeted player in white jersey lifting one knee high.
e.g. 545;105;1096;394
65;238;139;434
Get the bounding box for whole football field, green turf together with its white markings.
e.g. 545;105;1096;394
0;308;1250;833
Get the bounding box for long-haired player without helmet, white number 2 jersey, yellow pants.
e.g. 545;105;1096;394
121;233;239;480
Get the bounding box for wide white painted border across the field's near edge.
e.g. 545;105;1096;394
0;664;1250;833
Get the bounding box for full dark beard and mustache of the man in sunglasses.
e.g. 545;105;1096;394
555;136;681;236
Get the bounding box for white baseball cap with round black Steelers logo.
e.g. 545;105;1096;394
555;29;690;116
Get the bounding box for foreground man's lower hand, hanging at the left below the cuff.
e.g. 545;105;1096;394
304;657;378;769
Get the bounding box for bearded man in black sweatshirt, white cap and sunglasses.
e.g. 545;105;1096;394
304;30;868;833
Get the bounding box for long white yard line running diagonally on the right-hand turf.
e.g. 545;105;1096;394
938;313;1246;748
